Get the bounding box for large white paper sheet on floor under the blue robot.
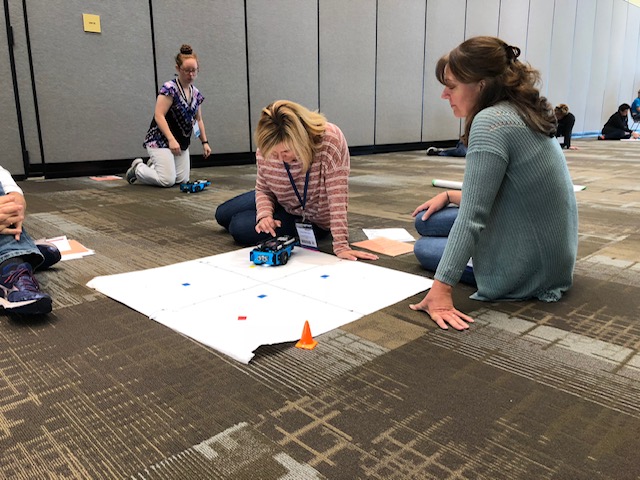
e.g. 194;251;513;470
87;247;433;363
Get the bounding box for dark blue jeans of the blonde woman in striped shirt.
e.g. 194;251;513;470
216;190;329;247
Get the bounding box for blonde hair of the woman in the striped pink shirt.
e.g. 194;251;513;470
255;100;327;172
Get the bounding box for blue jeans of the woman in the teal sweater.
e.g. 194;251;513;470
413;207;476;285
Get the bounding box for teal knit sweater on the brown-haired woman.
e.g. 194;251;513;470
435;102;578;302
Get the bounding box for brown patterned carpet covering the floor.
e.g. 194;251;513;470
0;140;640;480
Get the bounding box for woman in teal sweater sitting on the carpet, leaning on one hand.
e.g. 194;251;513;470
411;37;578;330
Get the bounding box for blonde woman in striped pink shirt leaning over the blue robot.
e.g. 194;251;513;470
215;100;378;260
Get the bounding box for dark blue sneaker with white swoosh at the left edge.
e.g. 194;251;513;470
0;262;51;315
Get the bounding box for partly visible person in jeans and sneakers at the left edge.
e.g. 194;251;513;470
0;167;61;315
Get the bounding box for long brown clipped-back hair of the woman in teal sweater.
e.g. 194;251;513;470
436;36;557;143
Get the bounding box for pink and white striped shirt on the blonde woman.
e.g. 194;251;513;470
256;123;350;255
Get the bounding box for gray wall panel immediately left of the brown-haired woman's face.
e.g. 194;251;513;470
422;0;466;141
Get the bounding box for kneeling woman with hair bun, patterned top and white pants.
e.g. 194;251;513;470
126;45;211;187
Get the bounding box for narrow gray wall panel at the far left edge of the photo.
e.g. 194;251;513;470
0;2;25;175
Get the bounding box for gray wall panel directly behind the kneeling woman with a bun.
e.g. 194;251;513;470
147;0;250;154
